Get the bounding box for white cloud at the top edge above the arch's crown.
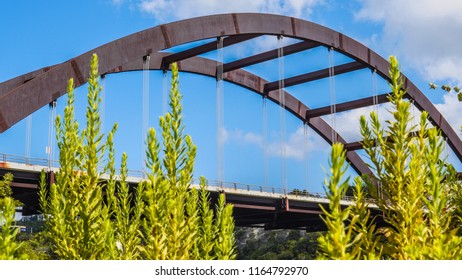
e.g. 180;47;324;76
135;0;325;22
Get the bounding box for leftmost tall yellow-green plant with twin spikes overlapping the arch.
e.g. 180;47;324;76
40;55;117;259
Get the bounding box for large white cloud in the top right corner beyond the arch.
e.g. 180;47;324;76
356;0;462;82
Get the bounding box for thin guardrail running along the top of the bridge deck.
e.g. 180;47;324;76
0;153;364;201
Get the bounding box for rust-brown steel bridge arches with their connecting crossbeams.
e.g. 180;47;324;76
0;13;462;177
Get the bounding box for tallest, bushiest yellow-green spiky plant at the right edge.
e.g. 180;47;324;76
361;56;461;259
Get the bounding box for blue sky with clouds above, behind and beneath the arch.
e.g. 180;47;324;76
0;0;462;194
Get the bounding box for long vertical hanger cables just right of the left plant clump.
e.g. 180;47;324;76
216;37;224;182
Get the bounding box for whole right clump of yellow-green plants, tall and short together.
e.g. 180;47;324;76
319;57;462;259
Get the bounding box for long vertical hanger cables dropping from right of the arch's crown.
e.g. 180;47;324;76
278;35;287;188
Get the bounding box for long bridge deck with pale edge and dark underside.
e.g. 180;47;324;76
0;154;377;231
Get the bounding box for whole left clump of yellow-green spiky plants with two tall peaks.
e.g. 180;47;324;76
40;54;235;259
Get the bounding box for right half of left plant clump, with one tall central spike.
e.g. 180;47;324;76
141;64;235;259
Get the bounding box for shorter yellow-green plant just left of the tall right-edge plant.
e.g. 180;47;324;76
318;143;377;260
